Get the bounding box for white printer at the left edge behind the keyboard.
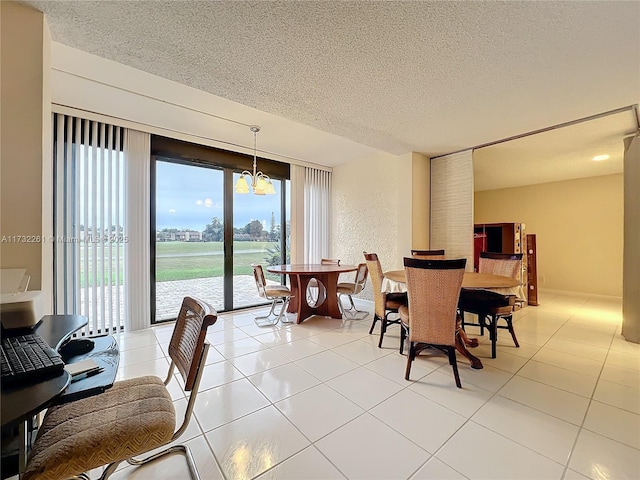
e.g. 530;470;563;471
0;268;43;329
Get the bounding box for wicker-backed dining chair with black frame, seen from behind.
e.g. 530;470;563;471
398;258;467;388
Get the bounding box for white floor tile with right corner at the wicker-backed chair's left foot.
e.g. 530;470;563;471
327;367;404;410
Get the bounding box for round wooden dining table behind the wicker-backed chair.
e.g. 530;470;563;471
382;270;520;369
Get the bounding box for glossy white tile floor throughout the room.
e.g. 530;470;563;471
107;293;640;480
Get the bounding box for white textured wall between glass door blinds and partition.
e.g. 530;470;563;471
331;150;411;300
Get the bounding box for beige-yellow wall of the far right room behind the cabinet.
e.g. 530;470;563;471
474;174;624;297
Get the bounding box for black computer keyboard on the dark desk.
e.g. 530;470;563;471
0;333;64;385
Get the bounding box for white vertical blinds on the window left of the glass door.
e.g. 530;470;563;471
53;114;127;334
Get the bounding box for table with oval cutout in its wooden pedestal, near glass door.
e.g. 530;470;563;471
267;264;358;323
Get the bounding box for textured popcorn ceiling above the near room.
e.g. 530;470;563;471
22;0;640;185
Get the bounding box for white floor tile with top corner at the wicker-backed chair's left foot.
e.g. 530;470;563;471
370;390;467;453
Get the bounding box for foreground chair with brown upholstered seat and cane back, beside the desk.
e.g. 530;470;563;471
20;297;217;480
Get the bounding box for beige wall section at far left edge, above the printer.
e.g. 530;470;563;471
0;2;51;296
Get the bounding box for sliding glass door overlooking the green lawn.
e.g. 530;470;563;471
152;156;289;322
